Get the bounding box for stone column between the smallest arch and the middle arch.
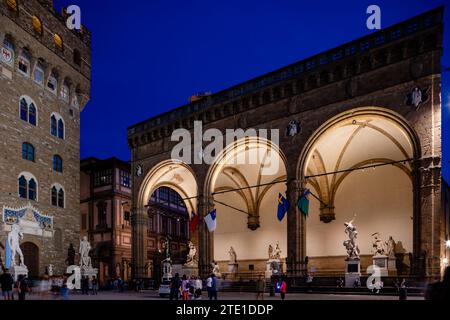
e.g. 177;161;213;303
197;196;214;277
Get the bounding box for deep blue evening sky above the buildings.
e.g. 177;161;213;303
55;0;450;180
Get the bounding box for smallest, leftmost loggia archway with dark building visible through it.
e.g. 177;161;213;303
133;160;198;281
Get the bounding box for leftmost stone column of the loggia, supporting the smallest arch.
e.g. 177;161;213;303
131;208;148;279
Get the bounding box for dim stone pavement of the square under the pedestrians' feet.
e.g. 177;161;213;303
22;291;423;301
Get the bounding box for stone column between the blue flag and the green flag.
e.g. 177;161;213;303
286;180;306;277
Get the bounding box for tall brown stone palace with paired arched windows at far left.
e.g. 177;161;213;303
0;0;91;277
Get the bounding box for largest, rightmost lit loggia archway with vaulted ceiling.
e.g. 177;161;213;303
300;108;419;274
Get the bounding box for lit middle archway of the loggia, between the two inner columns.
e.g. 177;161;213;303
205;137;287;273
